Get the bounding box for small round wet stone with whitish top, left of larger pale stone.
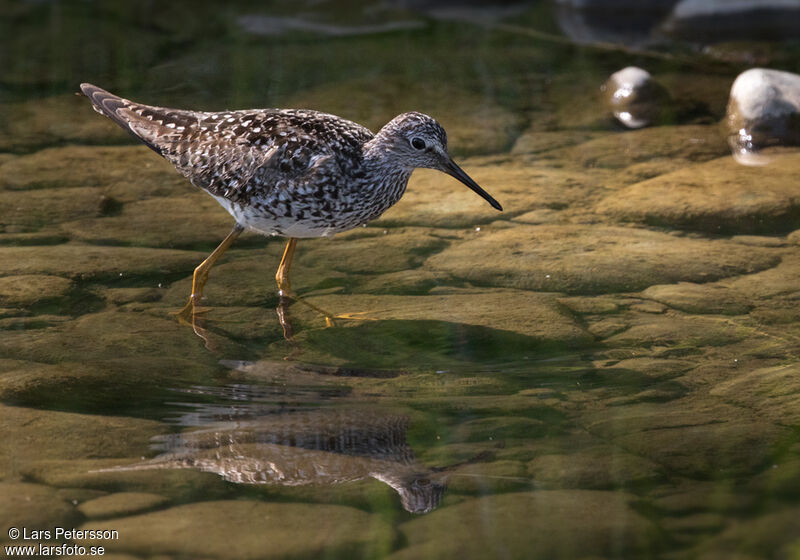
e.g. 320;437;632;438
600;66;669;128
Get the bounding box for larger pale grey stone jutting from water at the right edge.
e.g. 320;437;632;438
726;68;800;165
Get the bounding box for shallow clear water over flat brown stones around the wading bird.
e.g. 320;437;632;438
0;3;800;559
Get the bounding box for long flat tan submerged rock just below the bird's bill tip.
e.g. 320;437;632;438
426;225;779;294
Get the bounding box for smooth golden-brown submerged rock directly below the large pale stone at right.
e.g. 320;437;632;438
597;154;800;233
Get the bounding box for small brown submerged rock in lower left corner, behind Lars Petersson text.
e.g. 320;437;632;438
0;482;81;543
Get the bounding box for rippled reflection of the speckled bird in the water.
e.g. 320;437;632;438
100;408;482;513
